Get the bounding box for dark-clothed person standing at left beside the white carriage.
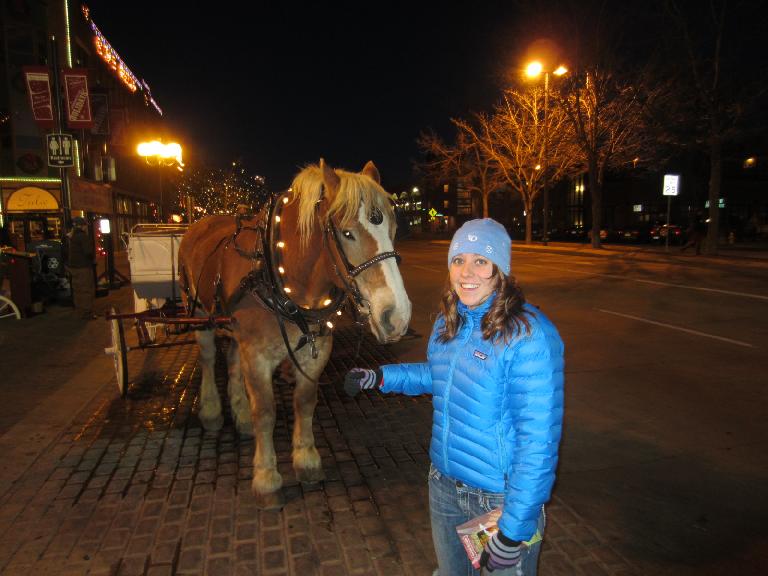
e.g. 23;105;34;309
67;216;98;320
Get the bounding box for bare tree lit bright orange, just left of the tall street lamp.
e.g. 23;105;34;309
455;88;580;243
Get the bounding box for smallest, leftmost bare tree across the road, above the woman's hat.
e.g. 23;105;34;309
417;127;503;218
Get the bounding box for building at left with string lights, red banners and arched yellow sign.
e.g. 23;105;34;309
0;0;171;250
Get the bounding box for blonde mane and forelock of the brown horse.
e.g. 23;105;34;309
291;164;394;245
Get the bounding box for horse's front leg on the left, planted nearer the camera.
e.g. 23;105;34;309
240;343;285;510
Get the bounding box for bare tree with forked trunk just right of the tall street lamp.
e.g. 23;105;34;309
560;66;652;248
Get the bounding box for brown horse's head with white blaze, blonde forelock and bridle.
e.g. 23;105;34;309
294;160;411;342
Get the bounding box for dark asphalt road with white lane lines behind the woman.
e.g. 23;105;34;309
406;242;768;575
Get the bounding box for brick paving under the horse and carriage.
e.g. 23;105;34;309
0;328;639;576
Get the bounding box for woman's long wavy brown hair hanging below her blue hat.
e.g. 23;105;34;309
437;264;531;343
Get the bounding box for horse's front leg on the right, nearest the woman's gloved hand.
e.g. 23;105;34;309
293;337;332;484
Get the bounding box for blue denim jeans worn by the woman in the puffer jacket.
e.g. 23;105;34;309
429;465;545;576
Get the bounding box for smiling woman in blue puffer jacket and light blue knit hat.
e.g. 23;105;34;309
345;218;563;576
